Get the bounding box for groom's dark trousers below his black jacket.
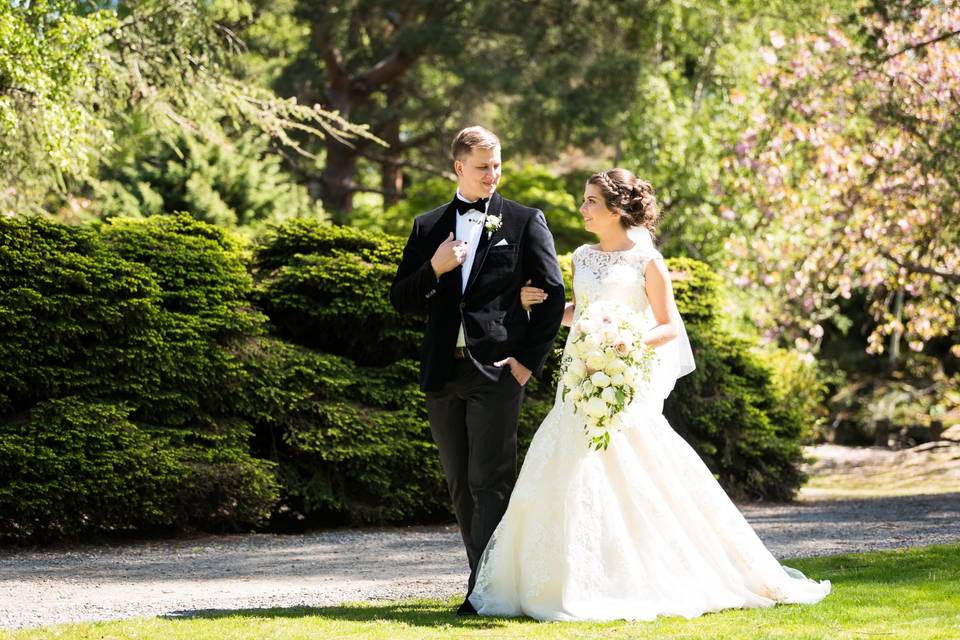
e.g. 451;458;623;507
426;360;523;594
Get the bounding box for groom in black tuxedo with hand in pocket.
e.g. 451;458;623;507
390;127;565;615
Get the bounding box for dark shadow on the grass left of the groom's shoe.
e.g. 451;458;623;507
163;601;529;629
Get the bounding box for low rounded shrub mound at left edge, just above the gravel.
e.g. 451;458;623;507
0;396;187;540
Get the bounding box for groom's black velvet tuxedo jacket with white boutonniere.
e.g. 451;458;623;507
390;193;565;391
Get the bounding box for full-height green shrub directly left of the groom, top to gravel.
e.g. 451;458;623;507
250;220;447;524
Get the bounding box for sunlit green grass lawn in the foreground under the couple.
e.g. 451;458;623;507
0;544;960;640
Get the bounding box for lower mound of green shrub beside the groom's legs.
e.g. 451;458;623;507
238;339;447;527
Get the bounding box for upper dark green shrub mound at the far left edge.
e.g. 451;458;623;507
0;218;160;414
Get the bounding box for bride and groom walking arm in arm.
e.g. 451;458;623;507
390;127;830;620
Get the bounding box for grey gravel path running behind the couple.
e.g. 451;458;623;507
0;492;960;628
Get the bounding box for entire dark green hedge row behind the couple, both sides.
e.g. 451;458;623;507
0;215;801;540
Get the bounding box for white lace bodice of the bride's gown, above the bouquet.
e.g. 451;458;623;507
573;245;660;319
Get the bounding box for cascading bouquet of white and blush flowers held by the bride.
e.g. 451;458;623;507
560;301;656;451
